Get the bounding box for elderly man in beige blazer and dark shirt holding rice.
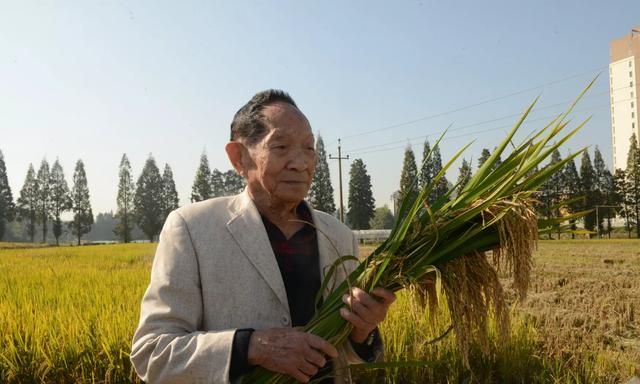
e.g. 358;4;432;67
131;90;395;383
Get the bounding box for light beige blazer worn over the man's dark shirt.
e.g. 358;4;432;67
131;190;370;383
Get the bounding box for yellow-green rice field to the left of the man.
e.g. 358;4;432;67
0;244;155;383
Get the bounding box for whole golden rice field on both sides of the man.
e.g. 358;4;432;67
0;240;640;383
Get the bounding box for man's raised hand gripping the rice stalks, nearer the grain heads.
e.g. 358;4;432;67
340;287;396;343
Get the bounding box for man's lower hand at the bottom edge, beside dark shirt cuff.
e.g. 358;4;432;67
247;328;338;383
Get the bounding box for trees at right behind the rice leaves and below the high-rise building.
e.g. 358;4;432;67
396;134;640;238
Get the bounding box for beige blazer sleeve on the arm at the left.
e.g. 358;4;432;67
131;211;235;384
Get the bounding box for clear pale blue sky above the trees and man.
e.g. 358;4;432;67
0;0;640;213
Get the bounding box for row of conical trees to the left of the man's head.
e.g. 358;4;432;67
0;151;244;245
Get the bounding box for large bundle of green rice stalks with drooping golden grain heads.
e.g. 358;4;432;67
245;79;595;383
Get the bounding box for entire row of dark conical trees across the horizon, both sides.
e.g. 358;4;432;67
0;134;640;244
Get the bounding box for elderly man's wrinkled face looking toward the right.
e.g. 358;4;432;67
245;102;316;205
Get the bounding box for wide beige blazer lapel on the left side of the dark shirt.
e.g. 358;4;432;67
227;190;289;312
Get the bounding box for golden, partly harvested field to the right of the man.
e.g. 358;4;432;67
359;240;640;383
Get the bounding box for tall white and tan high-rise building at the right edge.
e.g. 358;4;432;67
609;27;640;170
